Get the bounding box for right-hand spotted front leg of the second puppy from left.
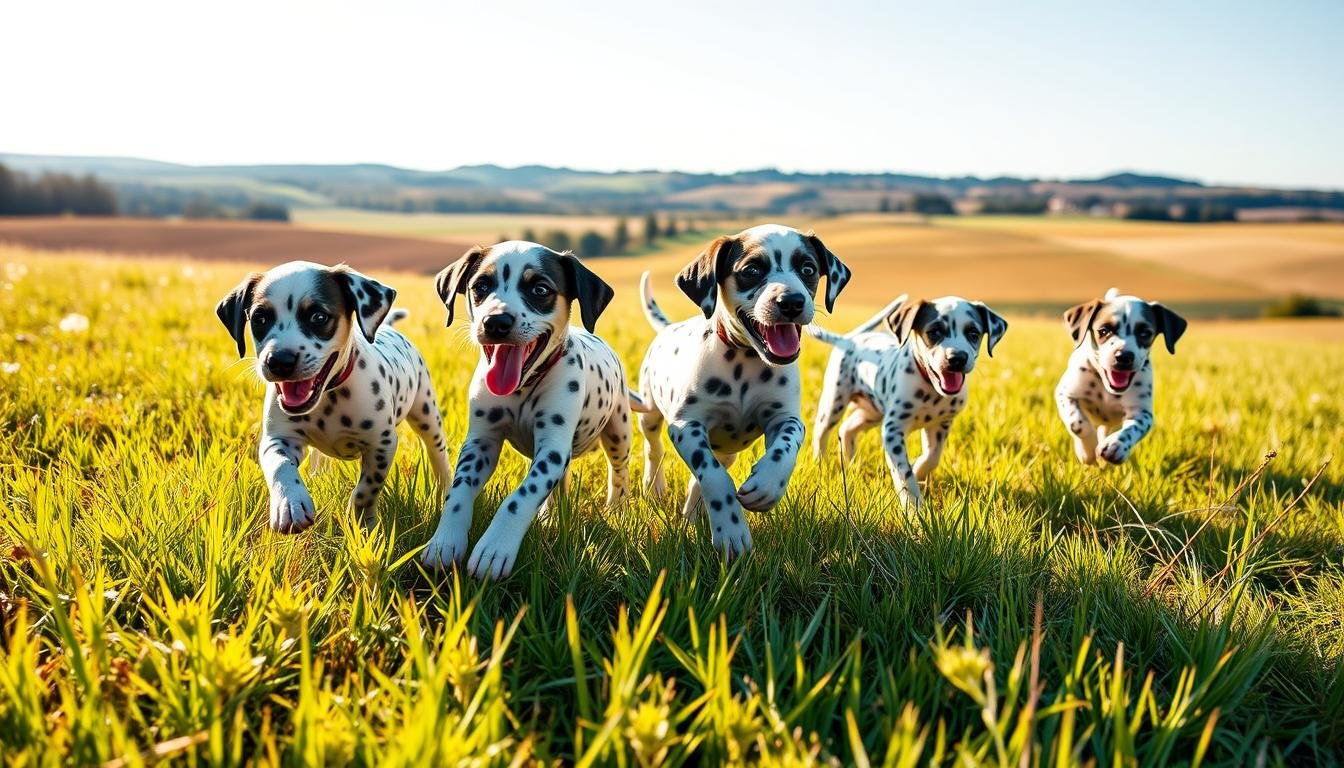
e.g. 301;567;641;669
466;435;575;578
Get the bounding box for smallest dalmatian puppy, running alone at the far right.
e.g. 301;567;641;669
1055;288;1187;464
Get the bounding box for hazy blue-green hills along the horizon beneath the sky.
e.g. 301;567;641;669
0;153;1344;215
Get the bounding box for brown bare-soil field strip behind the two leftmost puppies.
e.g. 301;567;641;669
0;218;472;273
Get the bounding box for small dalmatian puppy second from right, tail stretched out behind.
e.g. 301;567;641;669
808;296;1008;507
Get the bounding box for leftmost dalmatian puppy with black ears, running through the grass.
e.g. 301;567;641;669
215;261;449;533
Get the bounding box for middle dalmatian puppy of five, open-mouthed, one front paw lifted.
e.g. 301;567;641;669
640;225;849;557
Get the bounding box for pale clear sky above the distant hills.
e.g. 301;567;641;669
0;0;1344;188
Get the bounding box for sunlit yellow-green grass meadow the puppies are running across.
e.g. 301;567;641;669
0;248;1344;765
